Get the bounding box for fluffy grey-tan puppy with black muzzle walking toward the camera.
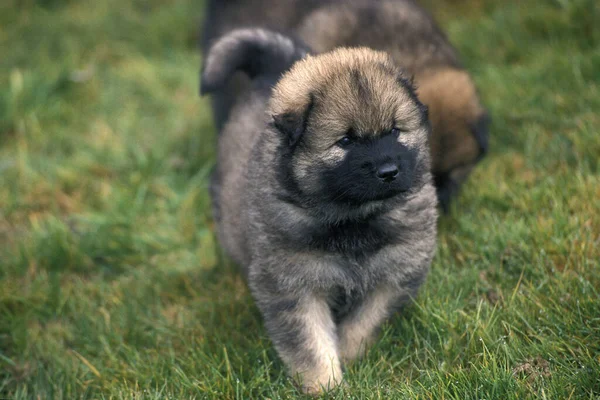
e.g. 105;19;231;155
202;29;437;394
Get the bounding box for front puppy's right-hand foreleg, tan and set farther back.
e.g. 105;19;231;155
338;287;400;362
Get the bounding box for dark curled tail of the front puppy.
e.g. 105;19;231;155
200;28;308;95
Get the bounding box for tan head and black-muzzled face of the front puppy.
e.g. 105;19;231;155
271;49;430;206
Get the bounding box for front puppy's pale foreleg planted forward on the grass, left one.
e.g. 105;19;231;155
259;294;342;394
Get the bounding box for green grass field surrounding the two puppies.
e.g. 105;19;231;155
0;0;600;400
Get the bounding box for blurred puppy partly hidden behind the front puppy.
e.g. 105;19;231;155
204;0;490;210
